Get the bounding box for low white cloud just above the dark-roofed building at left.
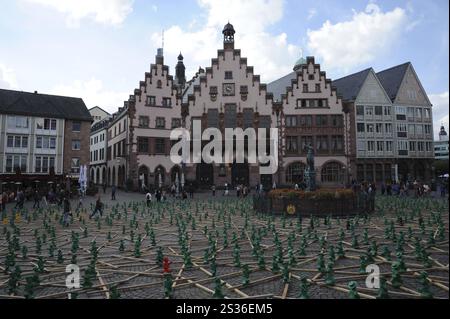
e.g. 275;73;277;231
48;78;130;113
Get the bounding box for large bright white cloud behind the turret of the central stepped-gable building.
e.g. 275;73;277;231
151;0;300;82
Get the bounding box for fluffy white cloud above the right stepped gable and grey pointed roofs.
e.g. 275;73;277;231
307;3;408;72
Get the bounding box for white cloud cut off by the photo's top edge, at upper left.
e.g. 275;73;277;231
26;0;134;27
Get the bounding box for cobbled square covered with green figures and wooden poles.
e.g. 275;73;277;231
0;192;449;299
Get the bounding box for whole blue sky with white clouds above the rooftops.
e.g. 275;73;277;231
0;0;449;135
